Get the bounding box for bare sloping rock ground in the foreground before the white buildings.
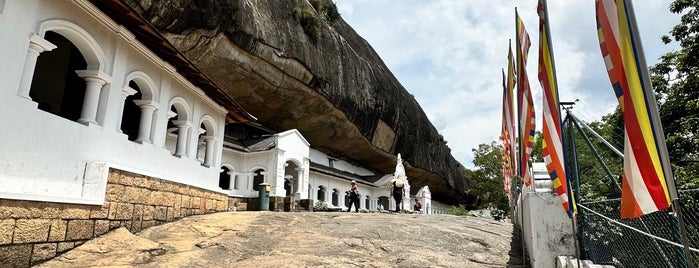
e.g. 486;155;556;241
37;212;522;267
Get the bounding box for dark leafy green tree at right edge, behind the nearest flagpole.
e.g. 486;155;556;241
650;0;699;188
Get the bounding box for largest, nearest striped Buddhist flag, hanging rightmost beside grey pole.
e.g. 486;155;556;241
595;0;674;218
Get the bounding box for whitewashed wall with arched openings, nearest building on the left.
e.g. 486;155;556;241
0;0;225;204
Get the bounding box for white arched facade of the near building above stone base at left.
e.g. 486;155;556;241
0;1;227;204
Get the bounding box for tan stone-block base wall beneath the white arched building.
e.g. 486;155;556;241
0;169;231;267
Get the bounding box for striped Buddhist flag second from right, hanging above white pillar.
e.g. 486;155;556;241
537;0;577;218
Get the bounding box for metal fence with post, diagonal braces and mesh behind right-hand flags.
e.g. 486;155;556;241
566;113;699;267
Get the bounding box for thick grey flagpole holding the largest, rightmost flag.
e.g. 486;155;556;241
623;0;694;268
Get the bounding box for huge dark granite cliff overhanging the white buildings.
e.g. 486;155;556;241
125;0;465;203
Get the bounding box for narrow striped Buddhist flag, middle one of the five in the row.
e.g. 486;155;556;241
515;9;536;186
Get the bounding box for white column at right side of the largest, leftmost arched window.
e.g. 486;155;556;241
75;70;111;125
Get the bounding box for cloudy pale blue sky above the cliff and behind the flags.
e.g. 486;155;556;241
334;0;680;168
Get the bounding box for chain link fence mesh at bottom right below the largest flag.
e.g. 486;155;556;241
578;189;699;267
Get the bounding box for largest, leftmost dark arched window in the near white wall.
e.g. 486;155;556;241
29;31;87;121
